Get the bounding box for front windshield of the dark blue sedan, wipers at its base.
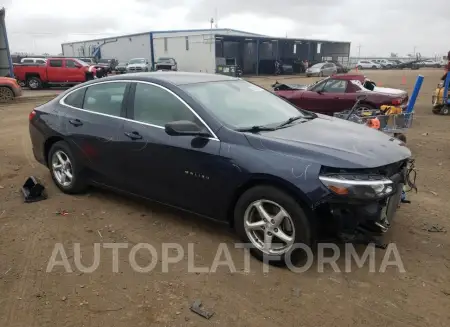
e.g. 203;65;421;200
181;80;309;129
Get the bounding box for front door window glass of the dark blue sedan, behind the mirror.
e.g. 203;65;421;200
134;83;201;126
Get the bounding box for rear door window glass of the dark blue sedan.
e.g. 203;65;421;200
83;83;127;117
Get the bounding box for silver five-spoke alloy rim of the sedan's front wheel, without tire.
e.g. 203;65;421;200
244;200;295;255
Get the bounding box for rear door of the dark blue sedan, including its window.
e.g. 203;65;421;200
62;82;130;188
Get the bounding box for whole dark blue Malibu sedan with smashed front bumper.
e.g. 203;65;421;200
29;72;411;263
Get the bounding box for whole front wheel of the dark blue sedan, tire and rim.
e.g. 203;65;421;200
234;185;311;265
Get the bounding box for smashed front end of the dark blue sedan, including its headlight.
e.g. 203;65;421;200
318;160;415;247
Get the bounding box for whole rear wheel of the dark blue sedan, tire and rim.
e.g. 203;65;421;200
47;141;87;194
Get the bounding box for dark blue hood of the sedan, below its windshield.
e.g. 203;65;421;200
246;115;411;169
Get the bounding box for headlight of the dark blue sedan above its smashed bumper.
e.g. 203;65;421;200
319;174;394;199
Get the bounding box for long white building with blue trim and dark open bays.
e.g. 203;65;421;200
61;29;350;75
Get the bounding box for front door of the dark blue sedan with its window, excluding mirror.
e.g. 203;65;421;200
124;82;223;215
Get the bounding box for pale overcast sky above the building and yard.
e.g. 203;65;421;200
0;0;450;57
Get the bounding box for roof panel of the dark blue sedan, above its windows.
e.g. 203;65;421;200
102;72;239;85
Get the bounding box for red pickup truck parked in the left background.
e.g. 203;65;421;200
14;58;94;90
